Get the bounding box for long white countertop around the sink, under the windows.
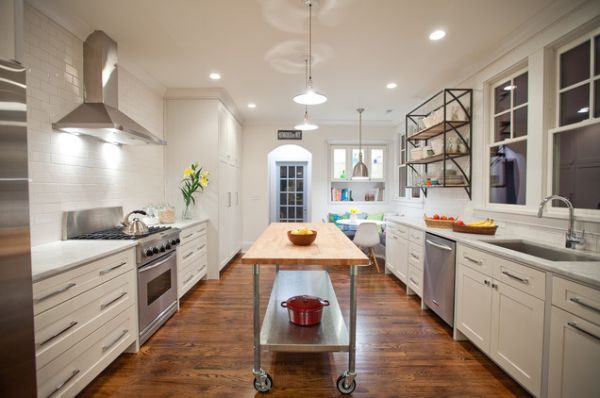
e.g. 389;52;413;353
386;216;600;288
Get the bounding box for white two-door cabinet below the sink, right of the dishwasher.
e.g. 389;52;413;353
456;244;545;396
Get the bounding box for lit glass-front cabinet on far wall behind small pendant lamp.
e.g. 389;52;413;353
330;145;387;182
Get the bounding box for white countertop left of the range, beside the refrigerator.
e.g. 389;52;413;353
31;240;136;283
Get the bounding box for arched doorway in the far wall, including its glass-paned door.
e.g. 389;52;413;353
267;145;312;222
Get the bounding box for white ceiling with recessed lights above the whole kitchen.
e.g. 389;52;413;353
36;0;573;124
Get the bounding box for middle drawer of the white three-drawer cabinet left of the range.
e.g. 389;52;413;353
34;270;137;369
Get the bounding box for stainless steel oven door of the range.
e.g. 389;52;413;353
138;251;177;344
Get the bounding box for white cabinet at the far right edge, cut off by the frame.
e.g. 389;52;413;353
548;278;600;398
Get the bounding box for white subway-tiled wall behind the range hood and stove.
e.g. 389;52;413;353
24;5;164;245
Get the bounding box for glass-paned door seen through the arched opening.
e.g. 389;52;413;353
276;162;307;222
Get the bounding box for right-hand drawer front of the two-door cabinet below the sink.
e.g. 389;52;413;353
494;257;546;300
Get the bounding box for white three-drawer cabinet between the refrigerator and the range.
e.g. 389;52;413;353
33;249;138;397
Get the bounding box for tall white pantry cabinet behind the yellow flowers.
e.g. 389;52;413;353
165;93;242;279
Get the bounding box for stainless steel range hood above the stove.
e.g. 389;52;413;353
52;30;167;145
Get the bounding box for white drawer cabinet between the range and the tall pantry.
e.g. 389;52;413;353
177;222;208;298
